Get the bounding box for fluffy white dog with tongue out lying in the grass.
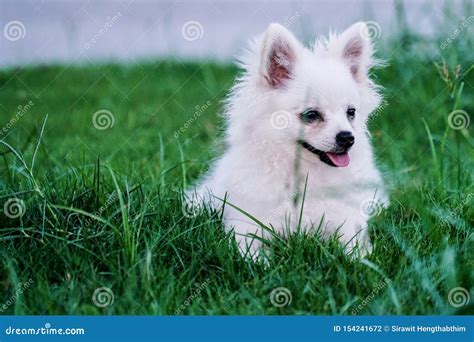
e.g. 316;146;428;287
193;22;387;257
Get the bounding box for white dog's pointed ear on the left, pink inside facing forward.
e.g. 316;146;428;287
260;24;302;88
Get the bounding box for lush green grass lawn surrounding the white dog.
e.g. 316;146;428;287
0;25;474;315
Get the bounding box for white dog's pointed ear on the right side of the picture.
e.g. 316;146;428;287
331;22;373;83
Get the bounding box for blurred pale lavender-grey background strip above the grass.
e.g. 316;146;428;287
0;0;466;67
